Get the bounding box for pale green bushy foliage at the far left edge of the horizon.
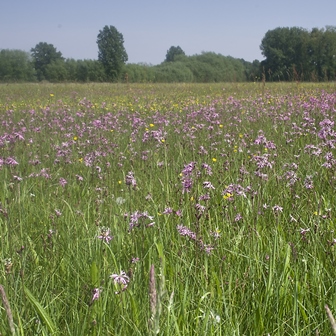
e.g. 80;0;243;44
0;49;35;82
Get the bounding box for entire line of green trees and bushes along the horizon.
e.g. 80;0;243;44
0;26;336;83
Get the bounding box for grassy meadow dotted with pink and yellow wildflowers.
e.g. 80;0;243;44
0;83;336;336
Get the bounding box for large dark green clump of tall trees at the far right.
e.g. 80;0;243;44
260;26;336;81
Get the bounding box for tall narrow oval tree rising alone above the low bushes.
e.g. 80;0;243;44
97;26;128;81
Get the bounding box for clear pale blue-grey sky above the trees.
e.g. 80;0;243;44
0;0;336;65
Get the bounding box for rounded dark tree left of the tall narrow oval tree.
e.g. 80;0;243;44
30;42;64;80
